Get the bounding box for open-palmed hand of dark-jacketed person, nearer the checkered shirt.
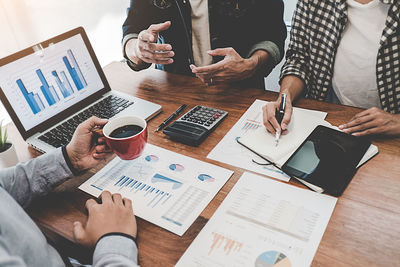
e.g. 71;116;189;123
190;47;258;85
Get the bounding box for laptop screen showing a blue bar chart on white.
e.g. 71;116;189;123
0;31;105;131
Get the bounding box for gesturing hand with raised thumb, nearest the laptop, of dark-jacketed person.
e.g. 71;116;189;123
126;21;175;65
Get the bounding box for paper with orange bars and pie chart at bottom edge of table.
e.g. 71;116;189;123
176;173;337;267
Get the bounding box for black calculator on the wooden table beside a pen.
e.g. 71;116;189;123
163;106;228;146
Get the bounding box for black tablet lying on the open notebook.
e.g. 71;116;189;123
282;125;371;196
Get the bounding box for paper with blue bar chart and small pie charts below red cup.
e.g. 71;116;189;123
79;144;233;235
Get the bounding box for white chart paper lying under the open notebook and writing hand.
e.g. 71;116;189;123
207;99;327;181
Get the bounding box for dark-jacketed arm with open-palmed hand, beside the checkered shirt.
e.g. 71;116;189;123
190;0;286;85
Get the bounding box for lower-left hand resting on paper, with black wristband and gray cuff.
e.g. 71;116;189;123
74;191;137;267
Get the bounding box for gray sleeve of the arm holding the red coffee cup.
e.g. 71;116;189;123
0;148;73;207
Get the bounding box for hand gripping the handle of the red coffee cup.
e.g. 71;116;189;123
66;117;111;171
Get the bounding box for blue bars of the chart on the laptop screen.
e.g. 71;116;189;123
16;50;88;114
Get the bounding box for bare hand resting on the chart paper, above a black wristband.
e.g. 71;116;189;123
73;191;137;248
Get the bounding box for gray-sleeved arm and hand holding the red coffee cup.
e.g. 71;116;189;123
0;117;110;207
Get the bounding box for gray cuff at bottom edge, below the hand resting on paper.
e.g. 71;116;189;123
93;235;138;267
